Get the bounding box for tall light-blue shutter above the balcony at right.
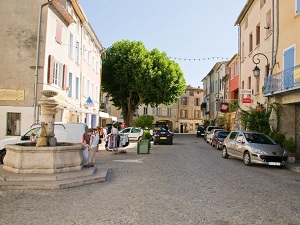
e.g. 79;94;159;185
283;47;295;89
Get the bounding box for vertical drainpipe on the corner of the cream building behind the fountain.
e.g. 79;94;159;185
33;0;51;123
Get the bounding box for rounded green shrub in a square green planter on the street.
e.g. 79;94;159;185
132;115;154;154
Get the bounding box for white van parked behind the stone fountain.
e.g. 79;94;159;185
0;122;88;164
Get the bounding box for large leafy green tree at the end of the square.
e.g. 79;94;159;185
102;40;186;125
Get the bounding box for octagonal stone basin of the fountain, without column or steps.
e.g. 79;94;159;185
3;143;83;174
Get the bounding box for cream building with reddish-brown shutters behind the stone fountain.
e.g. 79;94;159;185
0;0;108;139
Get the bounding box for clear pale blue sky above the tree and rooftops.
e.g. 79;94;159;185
79;0;247;88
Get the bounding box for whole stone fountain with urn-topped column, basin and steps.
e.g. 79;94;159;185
0;90;108;189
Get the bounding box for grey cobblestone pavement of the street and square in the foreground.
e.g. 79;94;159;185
0;134;300;225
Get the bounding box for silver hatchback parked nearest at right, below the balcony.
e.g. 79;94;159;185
222;131;288;166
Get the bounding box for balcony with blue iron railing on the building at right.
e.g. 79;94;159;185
263;65;300;96
